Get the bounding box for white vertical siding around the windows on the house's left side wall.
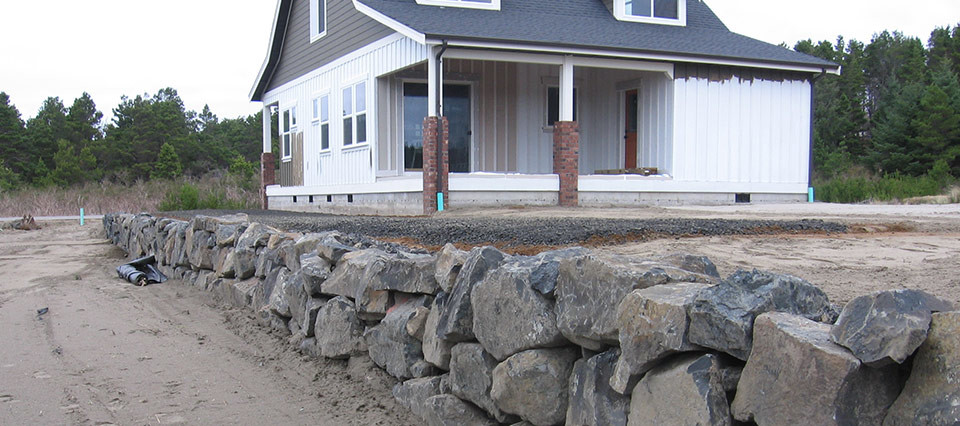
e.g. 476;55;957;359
264;34;427;186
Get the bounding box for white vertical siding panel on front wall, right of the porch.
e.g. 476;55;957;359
673;65;810;185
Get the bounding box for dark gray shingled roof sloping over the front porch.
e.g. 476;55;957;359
359;0;837;69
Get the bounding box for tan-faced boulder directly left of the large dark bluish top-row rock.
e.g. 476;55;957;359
610;283;710;394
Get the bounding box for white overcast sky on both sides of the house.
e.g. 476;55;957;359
0;0;960;119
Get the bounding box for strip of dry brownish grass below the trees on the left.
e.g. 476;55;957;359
0;173;259;217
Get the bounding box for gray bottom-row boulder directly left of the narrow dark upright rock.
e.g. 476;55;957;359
490;347;580;425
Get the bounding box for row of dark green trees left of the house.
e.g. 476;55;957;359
0;88;270;190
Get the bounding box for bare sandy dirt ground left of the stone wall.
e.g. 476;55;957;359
0;222;416;425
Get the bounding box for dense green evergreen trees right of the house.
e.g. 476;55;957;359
794;26;960;181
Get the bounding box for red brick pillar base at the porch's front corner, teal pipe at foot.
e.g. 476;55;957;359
423;117;450;214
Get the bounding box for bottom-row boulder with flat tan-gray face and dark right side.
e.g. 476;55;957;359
628;354;733;426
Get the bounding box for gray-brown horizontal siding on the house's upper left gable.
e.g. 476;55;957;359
267;0;394;90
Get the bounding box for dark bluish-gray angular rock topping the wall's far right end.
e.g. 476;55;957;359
830;290;953;367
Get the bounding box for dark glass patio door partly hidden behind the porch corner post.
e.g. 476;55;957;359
403;83;471;172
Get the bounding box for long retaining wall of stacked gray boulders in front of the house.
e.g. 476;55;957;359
103;214;960;425
